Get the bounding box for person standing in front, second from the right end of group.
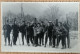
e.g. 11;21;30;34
57;22;67;49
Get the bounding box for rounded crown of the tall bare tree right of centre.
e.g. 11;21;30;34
44;5;62;21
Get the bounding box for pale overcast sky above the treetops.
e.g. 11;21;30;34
2;2;79;16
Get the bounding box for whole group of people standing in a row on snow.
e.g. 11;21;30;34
3;18;70;49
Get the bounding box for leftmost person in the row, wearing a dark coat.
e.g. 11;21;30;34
3;20;12;45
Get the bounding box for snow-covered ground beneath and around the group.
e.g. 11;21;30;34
1;31;80;52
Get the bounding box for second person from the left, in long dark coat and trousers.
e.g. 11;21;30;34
12;21;19;45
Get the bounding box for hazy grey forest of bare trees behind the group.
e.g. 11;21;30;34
2;6;78;30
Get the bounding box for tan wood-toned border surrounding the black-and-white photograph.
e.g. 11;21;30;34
0;0;80;54
